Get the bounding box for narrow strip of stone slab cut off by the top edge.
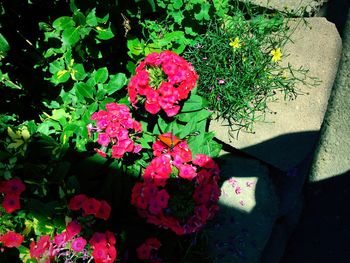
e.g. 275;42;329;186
243;0;327;15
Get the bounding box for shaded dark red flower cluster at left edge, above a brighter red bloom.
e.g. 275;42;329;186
0;178;26;214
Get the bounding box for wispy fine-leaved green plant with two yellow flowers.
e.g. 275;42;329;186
184;10;316;132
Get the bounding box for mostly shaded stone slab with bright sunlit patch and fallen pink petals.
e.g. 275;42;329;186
208;154;278;263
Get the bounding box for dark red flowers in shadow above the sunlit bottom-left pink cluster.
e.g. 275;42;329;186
68;194;111;220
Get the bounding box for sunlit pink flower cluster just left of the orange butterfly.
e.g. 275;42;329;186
87;103;142;158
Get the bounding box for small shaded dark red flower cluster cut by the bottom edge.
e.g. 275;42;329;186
136;237;163;263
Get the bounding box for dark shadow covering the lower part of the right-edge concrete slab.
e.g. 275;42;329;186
282;171;350;263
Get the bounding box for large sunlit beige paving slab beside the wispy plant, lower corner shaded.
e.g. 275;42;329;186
209;18;341;171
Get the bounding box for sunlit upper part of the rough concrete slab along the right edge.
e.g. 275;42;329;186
311;16;350;181
